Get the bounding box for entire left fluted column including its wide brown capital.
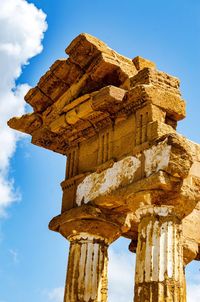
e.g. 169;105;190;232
49;205;133;302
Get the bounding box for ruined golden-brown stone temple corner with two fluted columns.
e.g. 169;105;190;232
8;34;200;302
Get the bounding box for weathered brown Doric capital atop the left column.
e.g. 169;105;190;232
49;205;131;244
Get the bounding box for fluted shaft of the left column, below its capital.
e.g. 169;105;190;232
64;233;108;302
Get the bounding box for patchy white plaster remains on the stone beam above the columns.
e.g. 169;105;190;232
76;140;171;206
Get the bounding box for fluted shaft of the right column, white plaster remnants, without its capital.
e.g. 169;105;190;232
134;206;186;302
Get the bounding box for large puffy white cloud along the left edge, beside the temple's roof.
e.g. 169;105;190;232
0;0;47;216
